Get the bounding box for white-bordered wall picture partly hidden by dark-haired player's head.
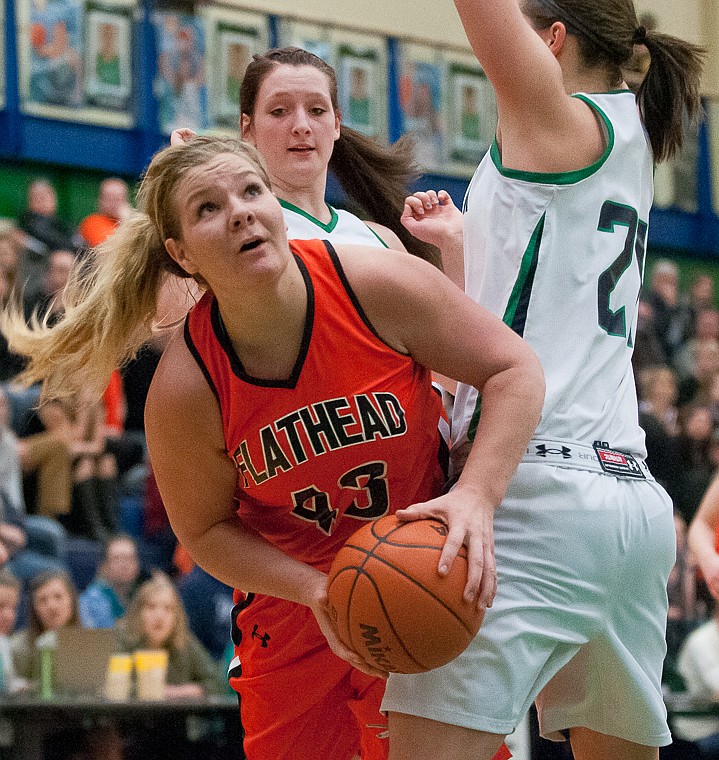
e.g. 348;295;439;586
201;6;269;134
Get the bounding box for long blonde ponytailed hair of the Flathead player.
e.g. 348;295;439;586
0;136;270;400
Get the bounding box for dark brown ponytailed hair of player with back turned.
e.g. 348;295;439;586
523;0;705;163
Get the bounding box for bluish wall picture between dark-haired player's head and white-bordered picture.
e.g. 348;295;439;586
399;43;447;172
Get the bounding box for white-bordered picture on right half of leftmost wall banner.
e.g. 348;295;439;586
85;3;132;111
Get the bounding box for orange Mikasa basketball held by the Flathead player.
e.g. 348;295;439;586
328;515;484;673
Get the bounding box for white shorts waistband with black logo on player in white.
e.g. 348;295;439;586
522;438;654;480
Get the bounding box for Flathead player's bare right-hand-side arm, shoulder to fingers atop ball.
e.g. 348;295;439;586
337;246;544;606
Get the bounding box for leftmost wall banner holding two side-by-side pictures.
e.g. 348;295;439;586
17;0;135;127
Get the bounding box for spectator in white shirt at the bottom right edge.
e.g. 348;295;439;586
678;608;719;760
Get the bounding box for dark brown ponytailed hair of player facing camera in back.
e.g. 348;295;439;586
240;47;441;268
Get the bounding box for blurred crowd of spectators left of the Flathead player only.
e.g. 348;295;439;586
0;178;232;758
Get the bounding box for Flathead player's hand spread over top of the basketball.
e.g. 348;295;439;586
396;485;497;609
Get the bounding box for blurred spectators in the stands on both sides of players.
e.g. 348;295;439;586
7;172;719;756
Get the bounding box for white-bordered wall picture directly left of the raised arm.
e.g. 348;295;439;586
447;60;497;174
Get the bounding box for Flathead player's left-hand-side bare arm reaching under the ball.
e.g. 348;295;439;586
145;330;383;675
